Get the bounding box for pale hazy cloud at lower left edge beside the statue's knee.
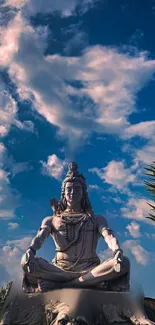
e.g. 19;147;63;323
0;237;32;280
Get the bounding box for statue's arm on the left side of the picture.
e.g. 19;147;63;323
29;217;52;254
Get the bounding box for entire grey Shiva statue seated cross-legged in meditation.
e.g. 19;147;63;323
21;162;130;293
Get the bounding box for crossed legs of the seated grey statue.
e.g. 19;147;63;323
21;249;130;292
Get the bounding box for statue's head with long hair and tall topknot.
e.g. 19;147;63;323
60;162;92;211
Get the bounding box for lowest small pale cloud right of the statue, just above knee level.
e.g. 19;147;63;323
122;240;150;265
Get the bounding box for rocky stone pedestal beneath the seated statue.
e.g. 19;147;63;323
0;284;155;325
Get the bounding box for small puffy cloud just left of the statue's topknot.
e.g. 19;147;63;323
41;154;67;180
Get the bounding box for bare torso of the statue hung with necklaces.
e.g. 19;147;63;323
51;214;99;270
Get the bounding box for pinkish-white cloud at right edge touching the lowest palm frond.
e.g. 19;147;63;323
121;198;154;223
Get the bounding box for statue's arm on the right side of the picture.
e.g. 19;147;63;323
96;216;122;255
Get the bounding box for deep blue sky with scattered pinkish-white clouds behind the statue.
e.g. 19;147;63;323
0;0;155;297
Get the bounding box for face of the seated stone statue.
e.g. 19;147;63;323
65;181;83;205
